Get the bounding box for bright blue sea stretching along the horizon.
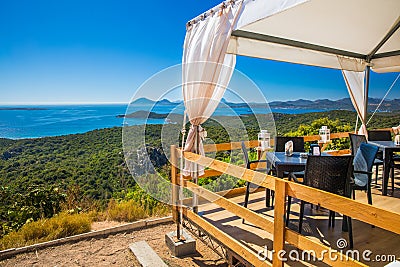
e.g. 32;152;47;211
0;104;323;139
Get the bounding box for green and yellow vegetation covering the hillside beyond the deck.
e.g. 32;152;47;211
0;111;400;248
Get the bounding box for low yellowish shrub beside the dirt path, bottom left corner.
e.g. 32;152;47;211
0;212;91;250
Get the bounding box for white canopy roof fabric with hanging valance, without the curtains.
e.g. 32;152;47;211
191;0;400;72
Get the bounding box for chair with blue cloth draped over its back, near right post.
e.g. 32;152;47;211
350;143;378;205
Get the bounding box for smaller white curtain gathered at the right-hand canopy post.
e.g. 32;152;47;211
342;70;367;135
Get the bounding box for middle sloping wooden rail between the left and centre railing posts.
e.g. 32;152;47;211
183;181;274;233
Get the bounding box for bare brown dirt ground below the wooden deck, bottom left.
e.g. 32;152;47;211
0;222;227;267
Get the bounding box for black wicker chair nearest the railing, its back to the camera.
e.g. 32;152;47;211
286;156;353;248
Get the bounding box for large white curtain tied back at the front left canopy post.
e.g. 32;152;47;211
182;1;242;176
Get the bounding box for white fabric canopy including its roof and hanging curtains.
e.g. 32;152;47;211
183;0;400;170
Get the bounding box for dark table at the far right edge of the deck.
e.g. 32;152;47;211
368;141;400;196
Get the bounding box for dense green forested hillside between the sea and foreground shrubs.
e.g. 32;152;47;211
0;111;400;203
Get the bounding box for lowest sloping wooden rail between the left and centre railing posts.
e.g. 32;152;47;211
184;209;272;267
